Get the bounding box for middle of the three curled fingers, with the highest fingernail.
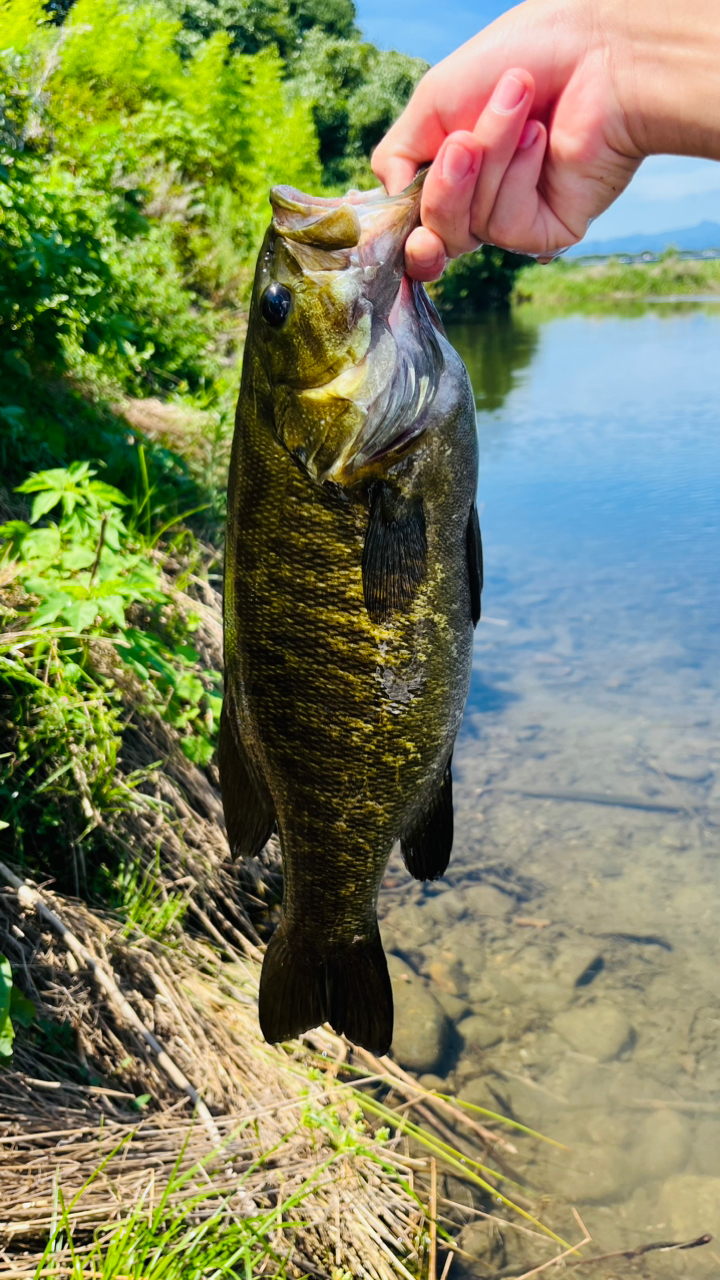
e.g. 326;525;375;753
470;68;534;239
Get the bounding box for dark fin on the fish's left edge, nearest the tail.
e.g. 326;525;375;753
218;692;275;858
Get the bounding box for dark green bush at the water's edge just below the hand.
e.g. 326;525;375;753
430;244;528;319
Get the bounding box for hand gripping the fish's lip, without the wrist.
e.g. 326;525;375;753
373;0;650;280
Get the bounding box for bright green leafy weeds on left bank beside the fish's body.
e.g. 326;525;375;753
0;462;222;896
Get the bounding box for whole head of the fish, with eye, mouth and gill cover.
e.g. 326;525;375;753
250;175;443;486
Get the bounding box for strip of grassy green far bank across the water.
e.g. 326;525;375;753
512;252;720;310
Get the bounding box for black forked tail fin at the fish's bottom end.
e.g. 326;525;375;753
259;920;393;1053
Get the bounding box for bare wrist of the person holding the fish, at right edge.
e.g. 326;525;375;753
609;0;720;160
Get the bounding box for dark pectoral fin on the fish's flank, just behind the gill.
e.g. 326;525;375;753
363;480;428;622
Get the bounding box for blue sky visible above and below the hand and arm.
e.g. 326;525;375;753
356;0;720;239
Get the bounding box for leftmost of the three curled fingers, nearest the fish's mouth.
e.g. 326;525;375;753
420;131;483;257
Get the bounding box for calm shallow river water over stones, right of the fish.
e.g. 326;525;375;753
380;308;720;1280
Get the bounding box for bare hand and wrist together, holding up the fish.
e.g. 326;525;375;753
373;0;720;280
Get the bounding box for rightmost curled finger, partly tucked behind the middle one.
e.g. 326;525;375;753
486;120;578;255
